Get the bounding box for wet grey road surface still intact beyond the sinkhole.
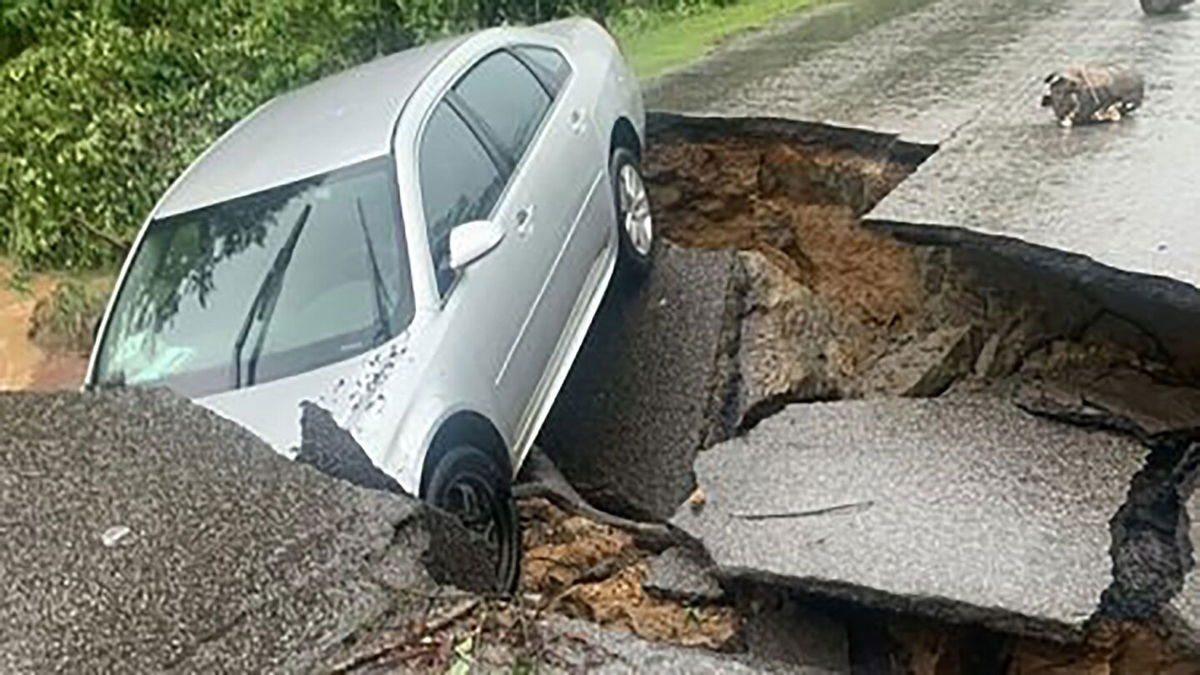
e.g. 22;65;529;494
648;0;1200;293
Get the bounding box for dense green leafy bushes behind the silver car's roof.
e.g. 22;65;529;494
0;0;725;269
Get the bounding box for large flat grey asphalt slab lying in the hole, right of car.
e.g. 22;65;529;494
672;396;1146;640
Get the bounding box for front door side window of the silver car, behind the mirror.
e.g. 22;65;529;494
418;101;505;294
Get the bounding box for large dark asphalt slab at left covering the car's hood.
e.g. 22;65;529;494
0;390;494;673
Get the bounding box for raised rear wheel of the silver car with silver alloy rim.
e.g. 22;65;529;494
608;148;658;279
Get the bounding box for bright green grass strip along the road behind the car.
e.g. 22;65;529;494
612;0;817;78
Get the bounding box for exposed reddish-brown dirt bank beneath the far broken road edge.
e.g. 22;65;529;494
646;123;1200;426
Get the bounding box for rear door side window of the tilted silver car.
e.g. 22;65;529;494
455;52;551;163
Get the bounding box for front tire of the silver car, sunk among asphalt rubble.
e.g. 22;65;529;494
427;444;521;593
